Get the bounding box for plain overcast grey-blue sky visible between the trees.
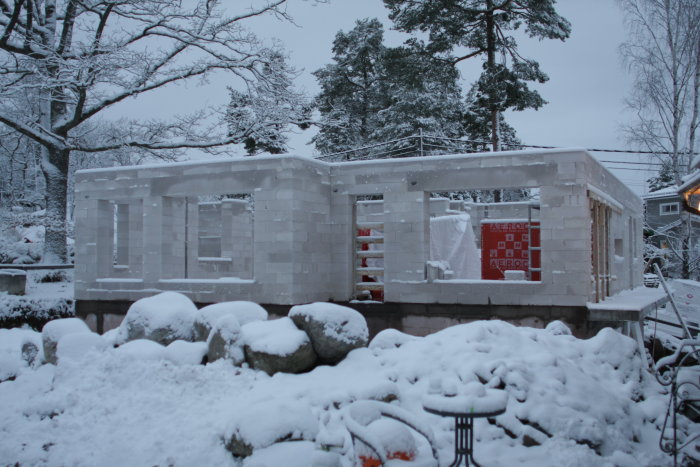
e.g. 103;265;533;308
115;0;651;194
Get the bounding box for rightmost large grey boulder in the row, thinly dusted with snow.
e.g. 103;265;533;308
289;302;369;364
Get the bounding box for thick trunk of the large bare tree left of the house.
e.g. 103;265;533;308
42;147;70;264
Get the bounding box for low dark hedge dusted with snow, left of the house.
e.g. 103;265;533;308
0;294;75;330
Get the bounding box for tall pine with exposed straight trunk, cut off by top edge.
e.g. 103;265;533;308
384;0;571;150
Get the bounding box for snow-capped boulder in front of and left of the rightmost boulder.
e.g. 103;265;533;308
241;317;317;375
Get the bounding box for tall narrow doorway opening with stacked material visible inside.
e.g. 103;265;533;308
353;195;384;302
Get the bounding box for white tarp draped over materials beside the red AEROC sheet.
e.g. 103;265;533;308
430;214;481;279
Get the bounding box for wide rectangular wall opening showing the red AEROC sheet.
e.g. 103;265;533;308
426;188;542;281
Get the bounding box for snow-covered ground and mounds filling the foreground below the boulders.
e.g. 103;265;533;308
0;321;670;467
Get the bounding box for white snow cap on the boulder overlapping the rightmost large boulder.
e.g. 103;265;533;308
241;317;309;355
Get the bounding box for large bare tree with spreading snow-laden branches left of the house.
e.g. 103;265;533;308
0;0;306;262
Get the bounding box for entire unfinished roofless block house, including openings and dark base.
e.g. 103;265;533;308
75;150;656;334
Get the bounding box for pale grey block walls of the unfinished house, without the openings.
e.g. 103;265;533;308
75;150;642;307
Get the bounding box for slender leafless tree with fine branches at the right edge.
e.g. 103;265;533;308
620;0;700;278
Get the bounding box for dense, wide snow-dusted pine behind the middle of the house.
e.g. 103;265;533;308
313;19;464;153
